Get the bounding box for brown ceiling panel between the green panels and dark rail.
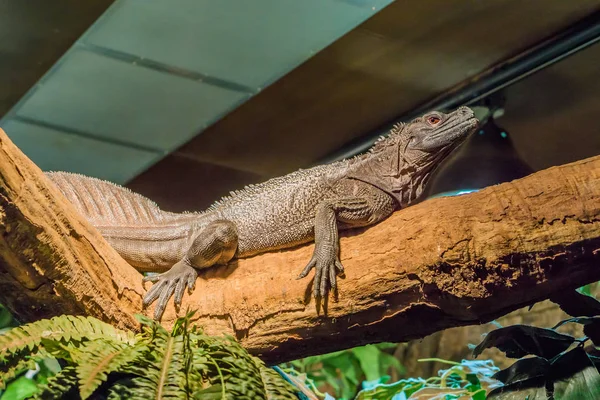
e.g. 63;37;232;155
171;0;600;176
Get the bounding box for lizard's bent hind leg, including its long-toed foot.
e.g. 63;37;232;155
143;220;238;320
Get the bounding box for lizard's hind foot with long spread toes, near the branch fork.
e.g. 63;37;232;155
142;260;198;321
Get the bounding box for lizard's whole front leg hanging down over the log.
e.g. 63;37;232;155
298;182;395;298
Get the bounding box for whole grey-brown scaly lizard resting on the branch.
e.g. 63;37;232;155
46;107;478;320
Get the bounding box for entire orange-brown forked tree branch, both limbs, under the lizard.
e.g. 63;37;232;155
0;132;600;363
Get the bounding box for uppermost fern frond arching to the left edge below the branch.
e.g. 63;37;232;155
0;315;135;360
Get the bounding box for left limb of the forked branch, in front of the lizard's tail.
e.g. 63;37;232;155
0;129;143;328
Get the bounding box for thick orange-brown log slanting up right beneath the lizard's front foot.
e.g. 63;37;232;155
182;152;600;361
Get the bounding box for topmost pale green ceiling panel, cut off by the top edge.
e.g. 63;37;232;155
83;0;391;89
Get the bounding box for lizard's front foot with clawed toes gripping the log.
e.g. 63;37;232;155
296;250;344;299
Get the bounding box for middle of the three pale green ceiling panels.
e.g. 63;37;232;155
16;47;248;151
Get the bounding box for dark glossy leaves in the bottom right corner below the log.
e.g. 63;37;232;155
474;291;600;400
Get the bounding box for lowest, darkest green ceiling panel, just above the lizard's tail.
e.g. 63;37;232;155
2;119;160;184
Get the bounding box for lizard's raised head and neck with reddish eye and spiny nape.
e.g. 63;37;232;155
351;107;479;206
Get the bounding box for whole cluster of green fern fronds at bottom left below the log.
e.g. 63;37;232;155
0;313;312;400
